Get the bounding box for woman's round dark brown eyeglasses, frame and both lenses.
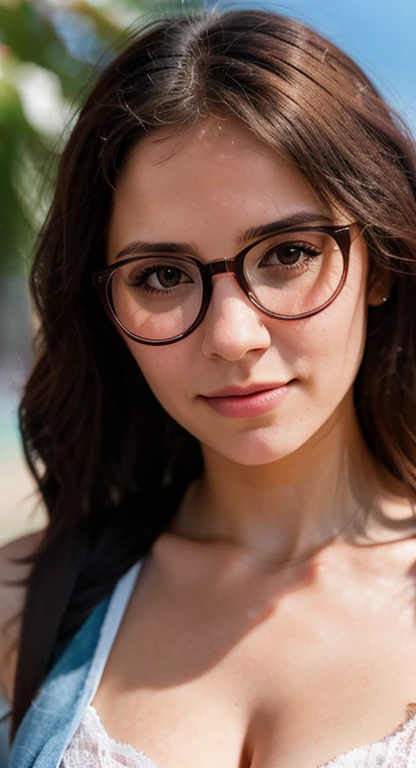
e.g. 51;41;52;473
92;224;352;345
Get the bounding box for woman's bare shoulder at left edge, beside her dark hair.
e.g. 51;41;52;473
0;531;43;701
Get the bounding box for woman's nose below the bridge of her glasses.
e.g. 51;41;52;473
201;273;271;361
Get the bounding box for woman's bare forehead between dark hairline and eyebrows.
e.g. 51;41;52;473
109;119;328;252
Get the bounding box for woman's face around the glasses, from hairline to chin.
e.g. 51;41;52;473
108;119;381;465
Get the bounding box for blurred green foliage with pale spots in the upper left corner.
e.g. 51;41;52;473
0;0;203;273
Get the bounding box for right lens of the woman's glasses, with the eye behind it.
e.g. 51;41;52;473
244;230;344;317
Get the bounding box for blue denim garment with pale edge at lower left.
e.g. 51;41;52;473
0;563;140;768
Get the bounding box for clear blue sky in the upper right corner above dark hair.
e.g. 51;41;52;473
219;0;416;134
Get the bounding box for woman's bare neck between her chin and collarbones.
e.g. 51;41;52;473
172;400;406;562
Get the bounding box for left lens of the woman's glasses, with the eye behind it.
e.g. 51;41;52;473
108;256;203;341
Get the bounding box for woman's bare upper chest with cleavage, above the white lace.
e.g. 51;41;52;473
94;556;416;768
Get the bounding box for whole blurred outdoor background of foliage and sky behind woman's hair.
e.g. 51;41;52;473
0;0;416;544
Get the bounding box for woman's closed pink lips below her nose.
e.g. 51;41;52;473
201;379;294;419
